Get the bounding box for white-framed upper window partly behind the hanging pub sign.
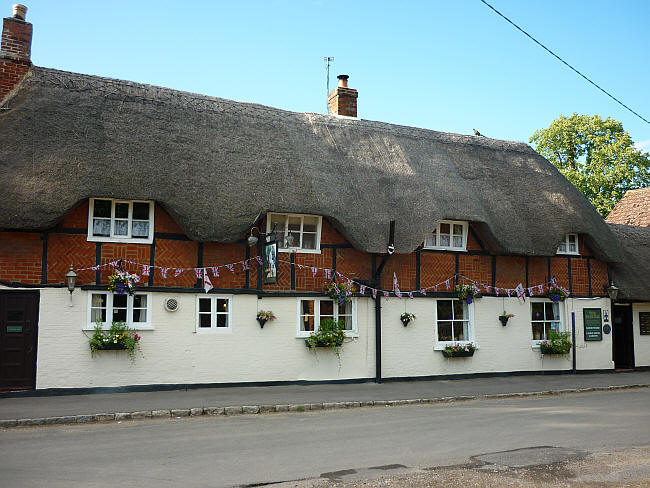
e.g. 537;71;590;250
266;213;322;253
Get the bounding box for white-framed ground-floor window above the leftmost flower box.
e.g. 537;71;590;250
87;292;151;329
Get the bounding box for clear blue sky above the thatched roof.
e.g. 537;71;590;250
13;0;650;150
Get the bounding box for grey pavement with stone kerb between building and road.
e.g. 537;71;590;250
0;371;650;422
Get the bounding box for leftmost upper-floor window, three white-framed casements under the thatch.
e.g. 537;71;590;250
88;198;154;244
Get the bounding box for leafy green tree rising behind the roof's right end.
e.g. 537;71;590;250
530;113;650;217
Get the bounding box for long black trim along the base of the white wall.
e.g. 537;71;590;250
0;366;650;398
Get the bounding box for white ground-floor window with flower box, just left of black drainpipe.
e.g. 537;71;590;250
297;298;358;337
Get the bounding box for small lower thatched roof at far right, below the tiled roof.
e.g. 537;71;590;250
609;224;650;302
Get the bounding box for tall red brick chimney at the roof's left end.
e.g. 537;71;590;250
0;4;32;103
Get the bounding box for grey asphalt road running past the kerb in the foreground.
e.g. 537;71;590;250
0;388;650;488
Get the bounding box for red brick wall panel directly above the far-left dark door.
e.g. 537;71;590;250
0;232;43;283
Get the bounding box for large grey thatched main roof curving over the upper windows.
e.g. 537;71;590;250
0;67;620;260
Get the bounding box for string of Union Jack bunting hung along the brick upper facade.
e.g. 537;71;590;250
75;256;569;298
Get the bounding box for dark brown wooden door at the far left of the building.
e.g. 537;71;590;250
0;291;39;390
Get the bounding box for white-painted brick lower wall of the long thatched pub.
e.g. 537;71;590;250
36;288;612;389
